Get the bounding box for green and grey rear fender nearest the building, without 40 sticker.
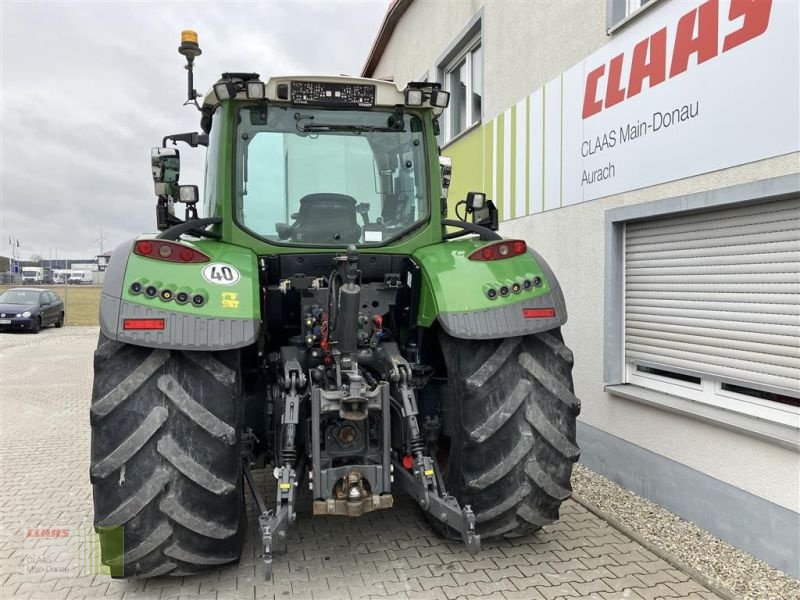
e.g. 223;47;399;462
412;240;567;339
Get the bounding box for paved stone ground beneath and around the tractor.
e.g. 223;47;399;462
0;327;717;600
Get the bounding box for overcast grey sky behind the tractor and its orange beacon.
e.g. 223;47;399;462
0;0;389;259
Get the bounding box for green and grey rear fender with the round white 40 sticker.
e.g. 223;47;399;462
100;235;261;350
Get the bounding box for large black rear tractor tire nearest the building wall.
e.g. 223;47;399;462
442;329;580;539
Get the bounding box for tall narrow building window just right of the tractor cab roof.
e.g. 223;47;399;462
444;38;483;141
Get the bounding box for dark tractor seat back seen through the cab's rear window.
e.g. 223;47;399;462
293;193;361;245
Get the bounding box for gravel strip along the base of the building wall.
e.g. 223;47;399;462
572;465;800;600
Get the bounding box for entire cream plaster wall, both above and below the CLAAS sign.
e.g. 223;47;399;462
373;0;800;512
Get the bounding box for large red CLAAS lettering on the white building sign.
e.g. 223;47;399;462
583;0;772;119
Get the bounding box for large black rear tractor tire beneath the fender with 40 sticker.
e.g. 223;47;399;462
91;333;245;578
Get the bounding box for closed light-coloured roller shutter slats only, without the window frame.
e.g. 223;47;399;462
625;198;800;397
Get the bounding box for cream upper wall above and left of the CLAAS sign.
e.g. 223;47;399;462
373;0;608;121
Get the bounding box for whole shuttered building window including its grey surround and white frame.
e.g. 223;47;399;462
604;178;800;447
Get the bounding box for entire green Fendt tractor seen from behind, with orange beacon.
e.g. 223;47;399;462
90;31;580;577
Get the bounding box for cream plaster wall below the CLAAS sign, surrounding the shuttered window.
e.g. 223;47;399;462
500;154;800;512
